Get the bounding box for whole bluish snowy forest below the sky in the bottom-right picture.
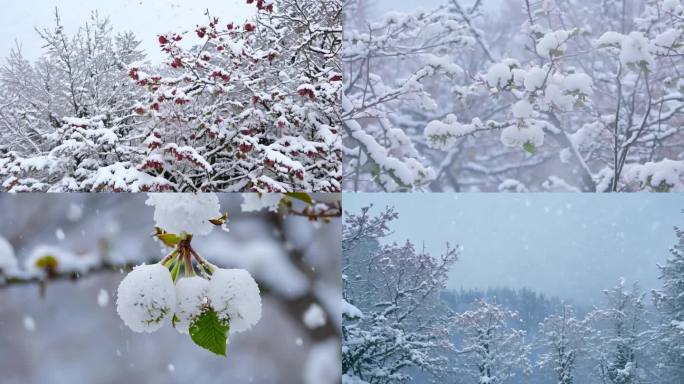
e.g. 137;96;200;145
342;208;684;384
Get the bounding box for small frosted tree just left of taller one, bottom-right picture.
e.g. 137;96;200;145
538;305;593;384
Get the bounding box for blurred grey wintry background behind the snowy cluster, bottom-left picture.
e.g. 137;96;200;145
0;194;341;384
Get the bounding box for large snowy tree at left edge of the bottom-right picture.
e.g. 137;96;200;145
342;208;458;384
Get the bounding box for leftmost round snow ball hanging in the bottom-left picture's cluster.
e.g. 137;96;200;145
116;264;176;332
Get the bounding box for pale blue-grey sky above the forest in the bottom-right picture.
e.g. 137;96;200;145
344;193;684;303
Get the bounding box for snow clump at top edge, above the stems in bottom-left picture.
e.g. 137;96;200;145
145;193;221;236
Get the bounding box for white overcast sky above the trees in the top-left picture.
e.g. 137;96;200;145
0;0;254;62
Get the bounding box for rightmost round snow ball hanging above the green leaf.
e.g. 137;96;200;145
207;269;261;332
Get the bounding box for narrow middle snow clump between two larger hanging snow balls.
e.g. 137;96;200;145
176;276;209;333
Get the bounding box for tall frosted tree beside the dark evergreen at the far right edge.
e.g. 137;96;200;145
589;279;652;384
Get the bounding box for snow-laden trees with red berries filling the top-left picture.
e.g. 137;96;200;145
0;0;342;192
